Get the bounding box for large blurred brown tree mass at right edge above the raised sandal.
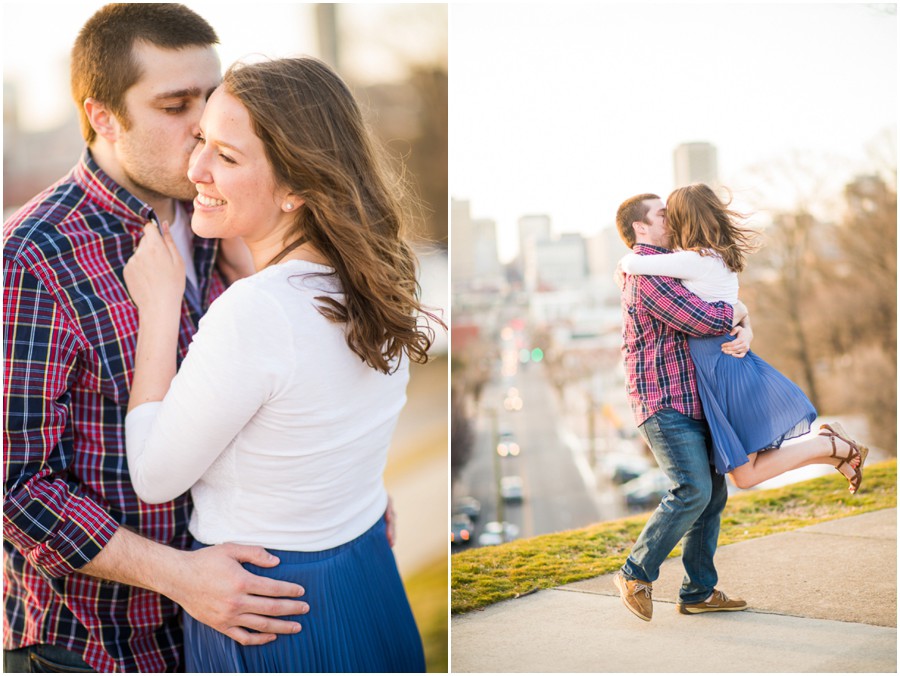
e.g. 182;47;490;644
741;176;897;453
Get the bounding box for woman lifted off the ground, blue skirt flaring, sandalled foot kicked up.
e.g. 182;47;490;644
622;183;868;493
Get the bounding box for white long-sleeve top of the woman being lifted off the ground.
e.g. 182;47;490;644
619;251;738;304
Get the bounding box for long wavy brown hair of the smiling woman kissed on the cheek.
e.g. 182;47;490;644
223;57;442;373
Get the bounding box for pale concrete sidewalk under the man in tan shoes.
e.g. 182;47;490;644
451;509;897;673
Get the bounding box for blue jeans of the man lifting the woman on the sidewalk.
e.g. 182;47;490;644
622;408;728;603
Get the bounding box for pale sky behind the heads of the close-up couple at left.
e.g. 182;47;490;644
2;0;447;130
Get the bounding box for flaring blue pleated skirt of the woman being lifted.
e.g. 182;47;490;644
688;334;817;474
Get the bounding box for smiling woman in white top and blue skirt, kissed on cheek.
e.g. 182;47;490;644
125;58;434;672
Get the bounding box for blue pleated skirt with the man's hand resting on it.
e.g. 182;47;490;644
184;517;425;673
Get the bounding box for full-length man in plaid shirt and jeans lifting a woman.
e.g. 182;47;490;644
615;193;747;621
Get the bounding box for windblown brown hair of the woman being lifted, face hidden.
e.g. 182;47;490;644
666;183;758;272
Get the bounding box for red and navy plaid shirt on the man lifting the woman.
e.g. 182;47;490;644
622;244;734;426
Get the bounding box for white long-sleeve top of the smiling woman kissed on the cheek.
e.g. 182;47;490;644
126;261;409;551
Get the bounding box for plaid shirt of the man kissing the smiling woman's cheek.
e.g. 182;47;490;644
3;150;224;672
